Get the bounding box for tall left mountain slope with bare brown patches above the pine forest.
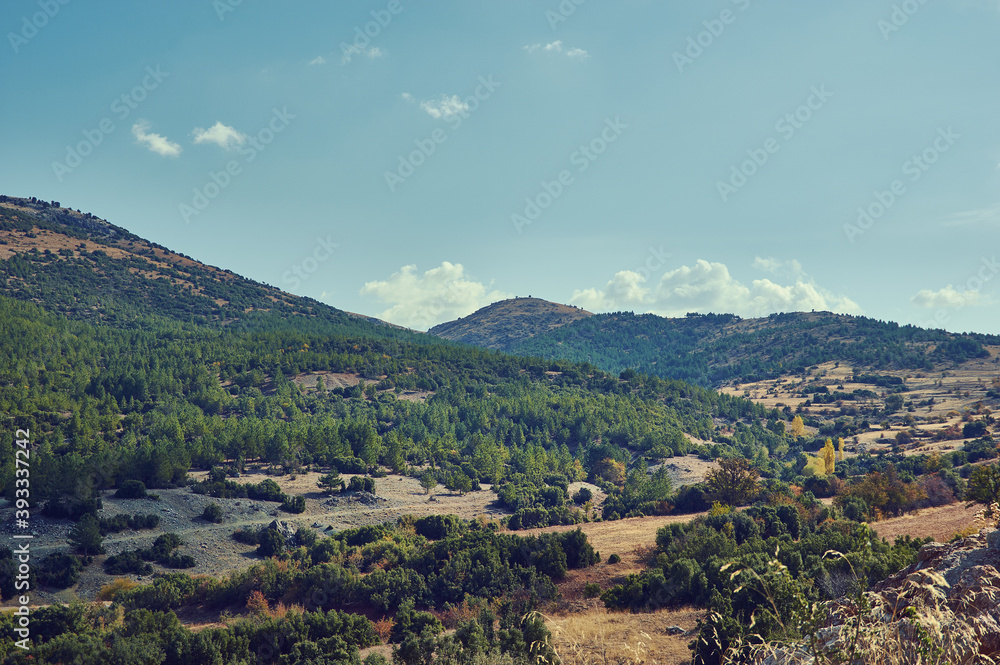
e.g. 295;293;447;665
0;196;398;333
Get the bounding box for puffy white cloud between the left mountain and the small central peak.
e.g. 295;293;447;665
361;261;513;330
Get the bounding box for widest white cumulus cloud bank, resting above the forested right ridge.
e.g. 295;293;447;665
570;259;861;317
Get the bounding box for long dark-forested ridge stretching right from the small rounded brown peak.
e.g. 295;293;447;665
444;312;1000;388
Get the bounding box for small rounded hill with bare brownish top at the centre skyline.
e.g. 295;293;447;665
427;296;593;351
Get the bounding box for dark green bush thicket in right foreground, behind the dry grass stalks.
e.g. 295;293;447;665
601;496;930;663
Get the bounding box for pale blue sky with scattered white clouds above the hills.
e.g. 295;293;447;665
0;0;1000;333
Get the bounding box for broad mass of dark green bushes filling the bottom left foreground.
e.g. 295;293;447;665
0;516;599;665
